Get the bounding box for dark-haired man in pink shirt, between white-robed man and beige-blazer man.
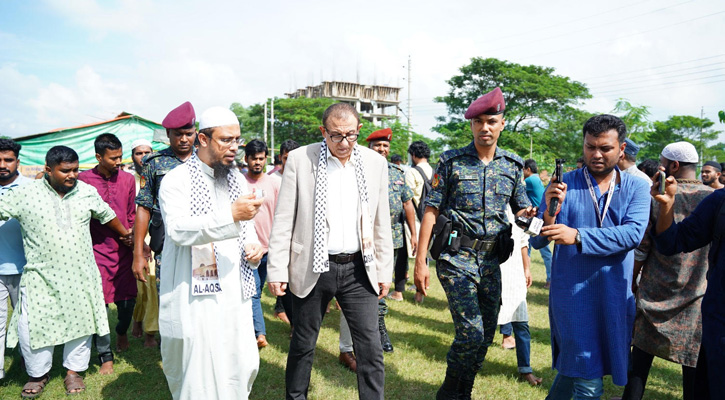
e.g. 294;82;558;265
244;139;282;348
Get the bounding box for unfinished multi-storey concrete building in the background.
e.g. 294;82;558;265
285;81;400;125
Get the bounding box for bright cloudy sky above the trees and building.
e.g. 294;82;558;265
0;0;725;141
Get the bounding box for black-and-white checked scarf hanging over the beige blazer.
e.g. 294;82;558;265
312;140;375;274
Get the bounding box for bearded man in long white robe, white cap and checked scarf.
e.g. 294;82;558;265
159;107;262;399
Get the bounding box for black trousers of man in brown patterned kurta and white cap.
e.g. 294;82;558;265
622;346;703;400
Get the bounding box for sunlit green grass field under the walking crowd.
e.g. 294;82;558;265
0;252;682;400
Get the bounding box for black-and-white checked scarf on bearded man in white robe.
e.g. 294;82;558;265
186;153;257;299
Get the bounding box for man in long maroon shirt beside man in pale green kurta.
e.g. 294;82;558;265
78;133;137;374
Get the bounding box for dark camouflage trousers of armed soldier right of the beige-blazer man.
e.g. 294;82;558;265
436;251;501;380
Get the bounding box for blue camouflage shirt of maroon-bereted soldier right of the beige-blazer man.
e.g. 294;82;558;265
425;142;531;240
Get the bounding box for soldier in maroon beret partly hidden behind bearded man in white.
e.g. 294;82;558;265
133;101;196;290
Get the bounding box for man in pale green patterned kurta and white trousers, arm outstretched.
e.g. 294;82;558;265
0;146;132;398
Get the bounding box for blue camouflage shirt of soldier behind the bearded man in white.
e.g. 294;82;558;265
136;147;184;211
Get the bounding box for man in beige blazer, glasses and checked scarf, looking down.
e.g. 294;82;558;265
267;103;393;400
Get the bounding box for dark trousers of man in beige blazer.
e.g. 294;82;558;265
285;255;385;400
